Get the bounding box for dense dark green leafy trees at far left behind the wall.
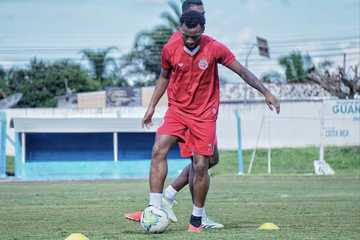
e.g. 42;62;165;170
8;58;96;107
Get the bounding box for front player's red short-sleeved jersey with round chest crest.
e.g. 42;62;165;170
162;32;235;121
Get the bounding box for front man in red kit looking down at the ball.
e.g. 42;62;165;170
143;11;280;232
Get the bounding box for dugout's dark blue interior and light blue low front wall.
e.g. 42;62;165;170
15;133;190;180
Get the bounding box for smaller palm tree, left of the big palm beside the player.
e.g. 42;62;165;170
80;47;117;86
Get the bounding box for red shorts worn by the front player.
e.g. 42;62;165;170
157;109;216;157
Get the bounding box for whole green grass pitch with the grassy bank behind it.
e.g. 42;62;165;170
0;148;360;240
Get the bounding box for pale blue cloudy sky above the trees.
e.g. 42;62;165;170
0;0;360;79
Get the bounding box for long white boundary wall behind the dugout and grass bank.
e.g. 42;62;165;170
6;101;360;155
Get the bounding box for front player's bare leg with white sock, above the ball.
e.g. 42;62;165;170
149;135;178;208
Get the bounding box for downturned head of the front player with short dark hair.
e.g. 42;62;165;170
180;11;205;50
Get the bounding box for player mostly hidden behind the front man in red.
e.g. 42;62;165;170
125;0;224;229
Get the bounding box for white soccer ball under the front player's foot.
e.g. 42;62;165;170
140;206;170;233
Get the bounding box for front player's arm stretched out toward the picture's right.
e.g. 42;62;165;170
226;60;280;113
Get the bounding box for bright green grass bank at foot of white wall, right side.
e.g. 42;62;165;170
212;146;360;175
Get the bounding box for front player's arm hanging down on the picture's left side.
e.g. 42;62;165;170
142;69;170;127
